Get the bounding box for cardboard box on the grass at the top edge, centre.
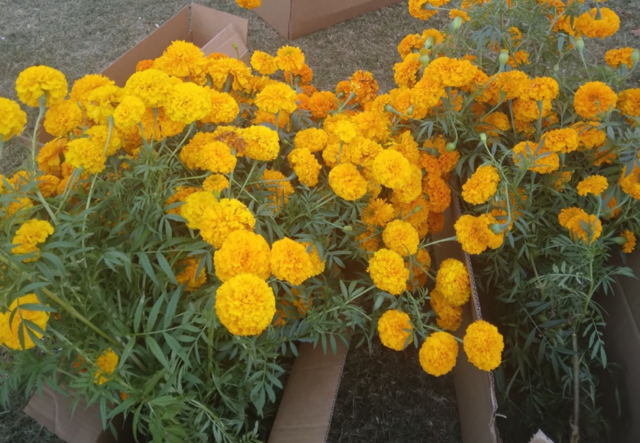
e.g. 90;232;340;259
254;0;401;40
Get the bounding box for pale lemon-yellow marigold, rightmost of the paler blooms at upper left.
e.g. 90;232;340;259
164;82;211;125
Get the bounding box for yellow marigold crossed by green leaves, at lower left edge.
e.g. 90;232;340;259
0;293;49;351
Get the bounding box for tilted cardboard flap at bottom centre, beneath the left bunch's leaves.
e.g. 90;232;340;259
269;340;347;443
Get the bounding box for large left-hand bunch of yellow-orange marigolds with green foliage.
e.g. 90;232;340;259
0;33;504;442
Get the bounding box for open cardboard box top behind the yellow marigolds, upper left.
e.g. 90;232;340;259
102;3;249;86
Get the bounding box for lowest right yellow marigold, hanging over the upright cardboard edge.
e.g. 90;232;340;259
463;320;504;372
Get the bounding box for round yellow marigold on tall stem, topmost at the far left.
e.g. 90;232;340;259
16;65;68;108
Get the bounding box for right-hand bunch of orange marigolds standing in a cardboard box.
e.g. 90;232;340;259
396;0;640;442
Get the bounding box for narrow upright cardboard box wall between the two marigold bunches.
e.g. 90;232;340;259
434;199;499;443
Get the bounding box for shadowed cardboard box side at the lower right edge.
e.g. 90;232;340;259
597;249;640;443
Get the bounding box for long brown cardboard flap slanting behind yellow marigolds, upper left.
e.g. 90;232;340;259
102;6;191;87
